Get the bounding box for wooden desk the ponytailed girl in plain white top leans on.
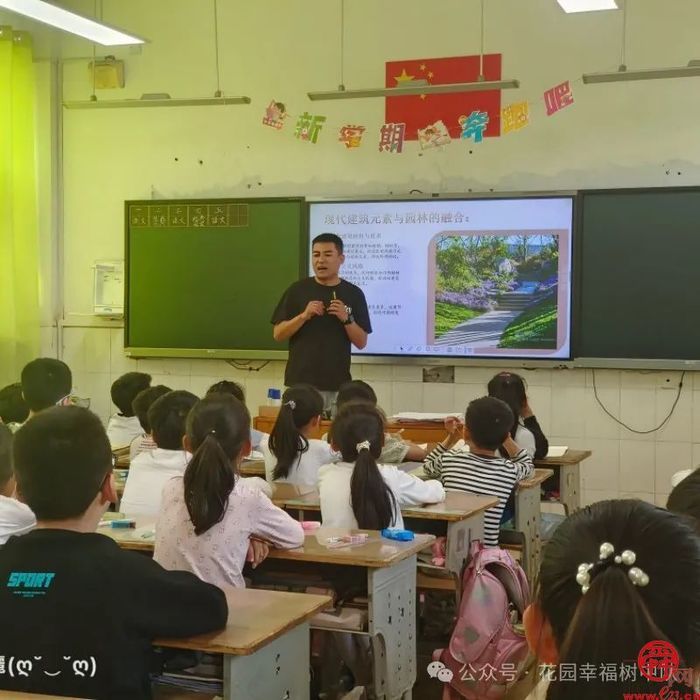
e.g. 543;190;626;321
272;484;498;582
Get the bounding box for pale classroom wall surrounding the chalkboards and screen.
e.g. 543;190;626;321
47;0;700;502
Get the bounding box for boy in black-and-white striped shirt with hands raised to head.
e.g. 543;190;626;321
424;396;534;547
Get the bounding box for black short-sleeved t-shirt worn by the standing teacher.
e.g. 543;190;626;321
272;277;372;391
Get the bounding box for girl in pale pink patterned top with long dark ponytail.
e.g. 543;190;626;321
154;394;304;587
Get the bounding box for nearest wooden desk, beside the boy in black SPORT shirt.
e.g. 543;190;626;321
154;588;332;700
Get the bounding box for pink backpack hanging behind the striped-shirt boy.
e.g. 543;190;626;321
433;541;530;700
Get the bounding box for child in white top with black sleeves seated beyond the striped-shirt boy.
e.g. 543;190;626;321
487;372;549;459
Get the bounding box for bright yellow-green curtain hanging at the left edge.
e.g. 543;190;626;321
0;26;40;386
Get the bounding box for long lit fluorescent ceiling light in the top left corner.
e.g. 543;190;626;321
0;0;145;46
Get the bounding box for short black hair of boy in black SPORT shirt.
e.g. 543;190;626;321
13;406;112;520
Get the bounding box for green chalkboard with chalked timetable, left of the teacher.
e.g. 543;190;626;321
125;198;307;359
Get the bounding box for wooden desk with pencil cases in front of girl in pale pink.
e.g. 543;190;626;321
104;518;435;700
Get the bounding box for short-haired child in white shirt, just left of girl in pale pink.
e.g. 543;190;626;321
120;391;198;515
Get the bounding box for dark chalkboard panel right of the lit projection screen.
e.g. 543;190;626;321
576;188;700;366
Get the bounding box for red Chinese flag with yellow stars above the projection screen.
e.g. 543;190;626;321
384;54;501;141
